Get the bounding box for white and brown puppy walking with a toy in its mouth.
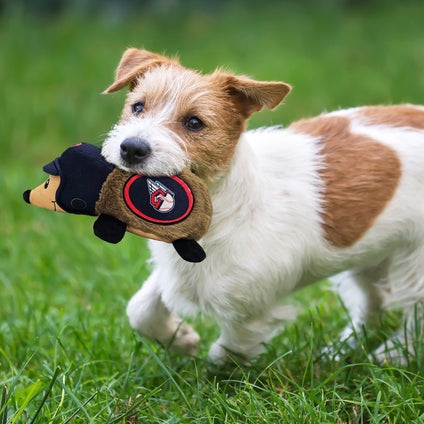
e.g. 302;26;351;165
102;48;424;365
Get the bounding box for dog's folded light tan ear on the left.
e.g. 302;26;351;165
103;48;176;94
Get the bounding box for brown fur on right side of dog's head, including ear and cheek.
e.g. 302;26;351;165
174;71;290;177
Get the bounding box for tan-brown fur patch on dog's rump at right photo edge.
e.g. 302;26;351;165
359;105;424;130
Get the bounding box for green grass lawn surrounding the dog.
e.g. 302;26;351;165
0;1;424;424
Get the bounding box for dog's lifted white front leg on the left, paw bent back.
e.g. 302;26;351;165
127;271;200;355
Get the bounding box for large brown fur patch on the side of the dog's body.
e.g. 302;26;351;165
290;116;401;247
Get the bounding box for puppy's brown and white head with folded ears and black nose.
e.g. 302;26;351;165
102;48;290;179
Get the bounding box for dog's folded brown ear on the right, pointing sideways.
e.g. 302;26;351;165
213;71;291;118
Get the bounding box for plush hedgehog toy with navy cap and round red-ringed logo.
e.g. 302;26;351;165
24;143;212;262
